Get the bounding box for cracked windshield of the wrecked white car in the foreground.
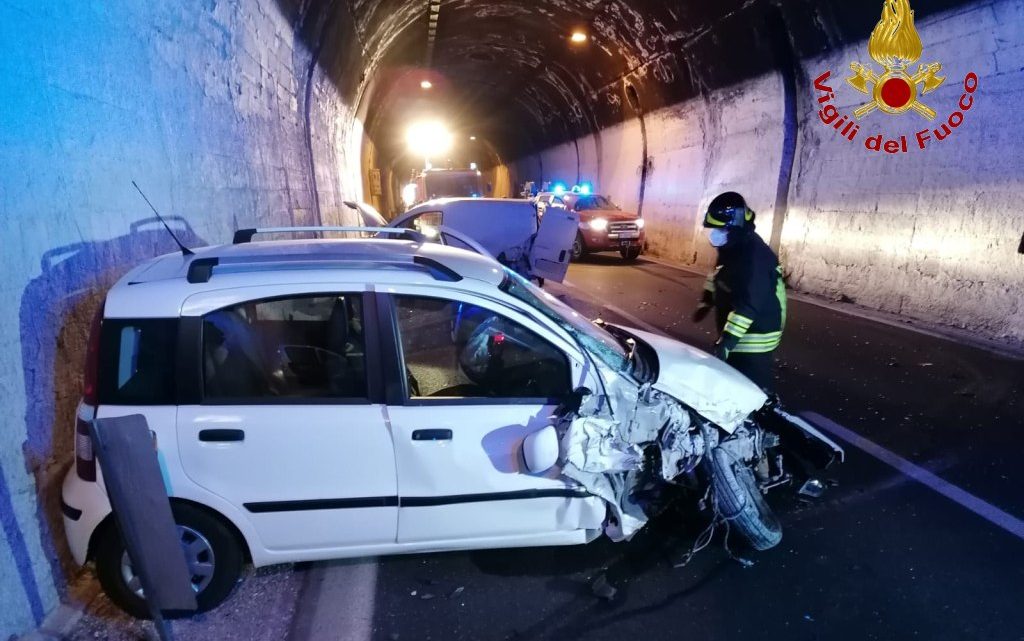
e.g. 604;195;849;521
501;269;631;374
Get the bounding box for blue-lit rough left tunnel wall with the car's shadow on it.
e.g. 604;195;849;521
0;0;361;638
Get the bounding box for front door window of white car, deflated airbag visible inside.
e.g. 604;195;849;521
395;296;571;399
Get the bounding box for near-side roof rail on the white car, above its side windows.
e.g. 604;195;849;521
185;254;462;285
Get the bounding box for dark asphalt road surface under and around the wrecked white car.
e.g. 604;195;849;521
54;255;1024;641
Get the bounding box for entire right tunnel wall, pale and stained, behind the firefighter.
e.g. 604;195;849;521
515;0;1024;343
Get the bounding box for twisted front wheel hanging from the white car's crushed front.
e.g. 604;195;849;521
711;447;782;552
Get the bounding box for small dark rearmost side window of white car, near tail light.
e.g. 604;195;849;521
99;318;178;405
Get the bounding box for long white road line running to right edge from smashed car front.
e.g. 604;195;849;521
803;412;1024;540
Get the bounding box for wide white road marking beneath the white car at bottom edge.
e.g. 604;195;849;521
292;559;378;641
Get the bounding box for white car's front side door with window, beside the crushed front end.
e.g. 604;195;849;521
381;288;604;545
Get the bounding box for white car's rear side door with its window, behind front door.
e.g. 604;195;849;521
177;288;397;558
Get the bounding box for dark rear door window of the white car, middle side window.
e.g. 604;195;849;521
203;294;367;403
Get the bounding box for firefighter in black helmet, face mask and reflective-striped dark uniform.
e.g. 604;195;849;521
693;191;785;395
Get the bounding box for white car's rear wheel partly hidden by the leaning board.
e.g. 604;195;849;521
93;503;245;618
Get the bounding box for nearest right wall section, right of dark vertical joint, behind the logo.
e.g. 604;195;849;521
782;0;1024;343
